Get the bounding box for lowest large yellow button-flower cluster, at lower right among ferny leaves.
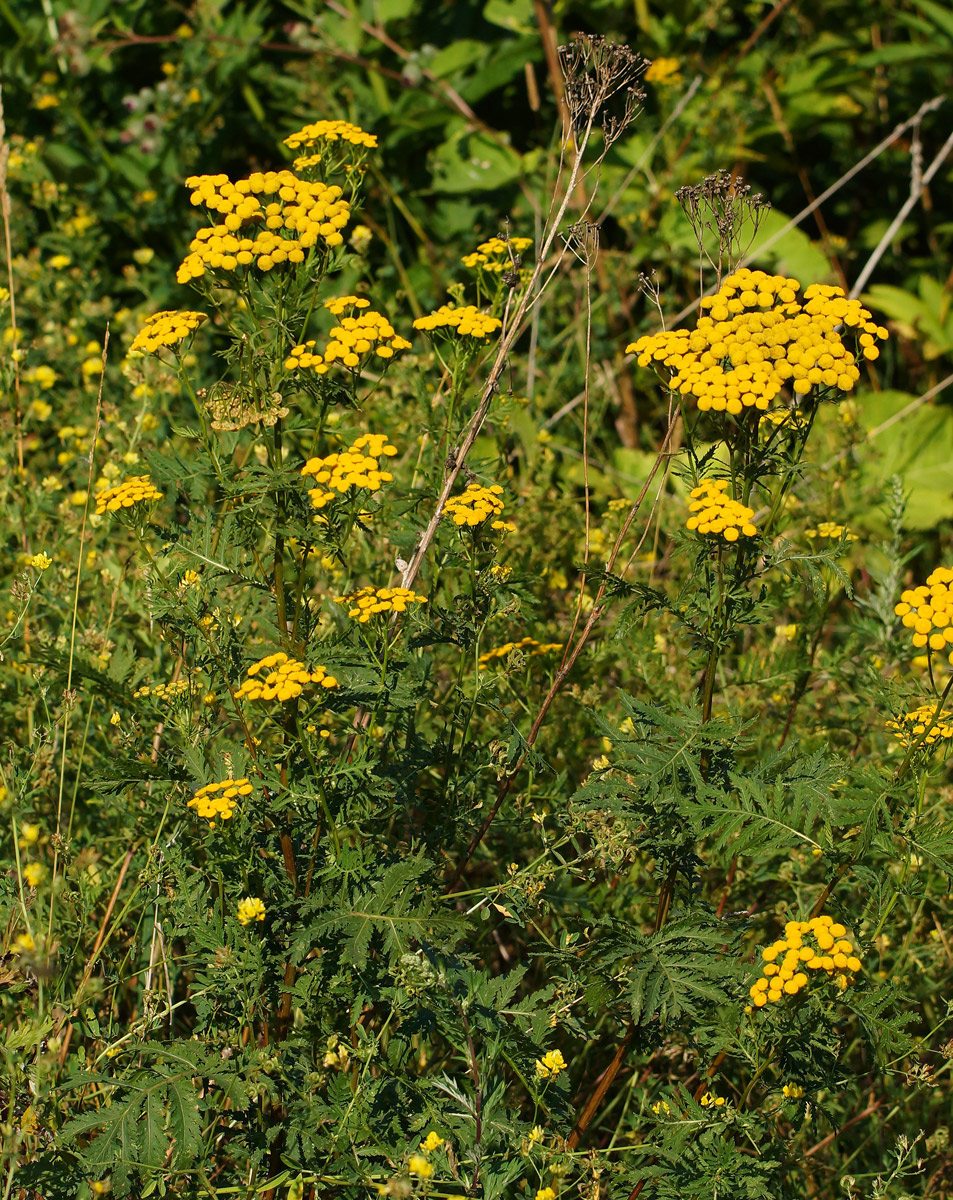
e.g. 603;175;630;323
750;917;862;1008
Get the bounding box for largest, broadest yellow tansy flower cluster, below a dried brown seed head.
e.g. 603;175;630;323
625;268;887;415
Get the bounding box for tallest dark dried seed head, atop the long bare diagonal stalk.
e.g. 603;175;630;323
558;34;648;149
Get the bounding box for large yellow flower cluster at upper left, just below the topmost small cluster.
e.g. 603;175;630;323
176;170;350;283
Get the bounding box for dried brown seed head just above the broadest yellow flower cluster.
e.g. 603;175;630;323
675;168;771;284
